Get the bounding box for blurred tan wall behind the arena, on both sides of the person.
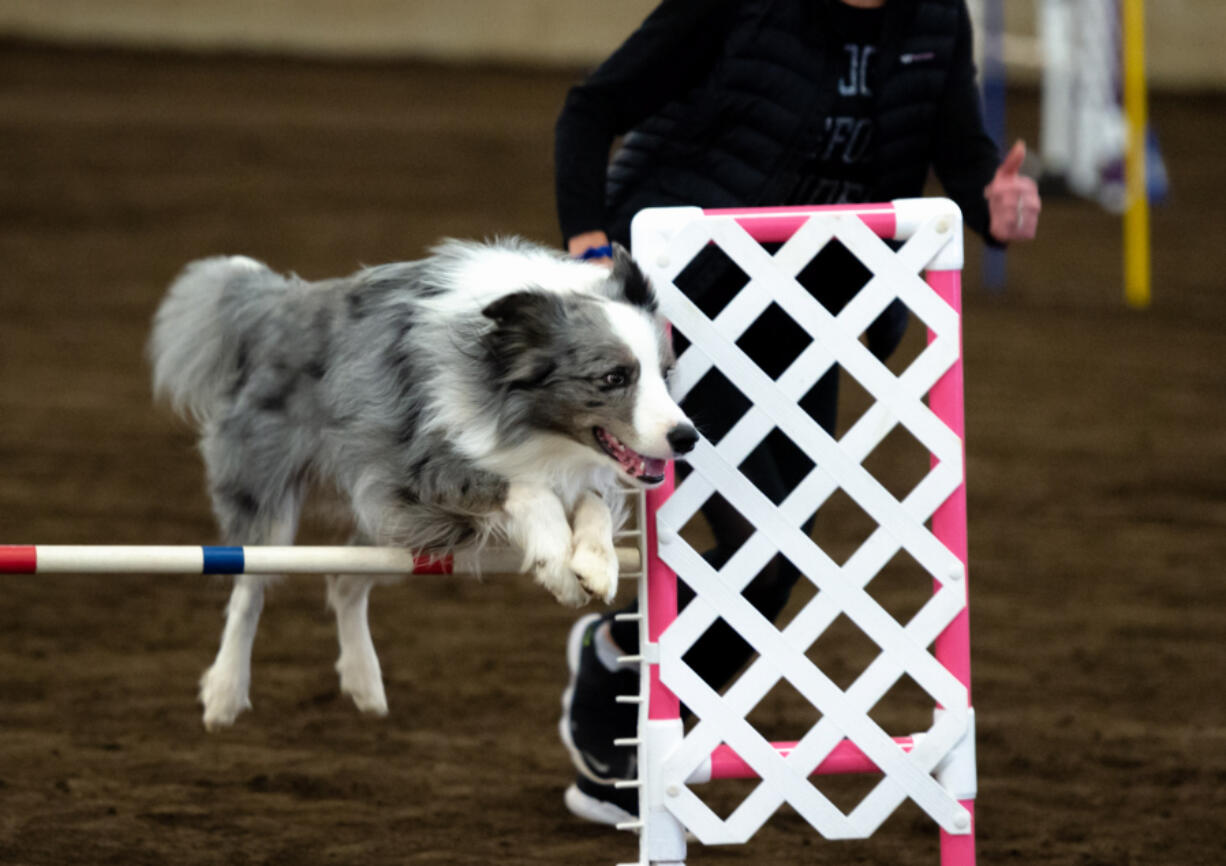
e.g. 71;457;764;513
0;0;1226;90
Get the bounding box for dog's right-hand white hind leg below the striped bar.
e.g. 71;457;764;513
327;559;387;715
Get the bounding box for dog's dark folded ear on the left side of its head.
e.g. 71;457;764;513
482;289;566;388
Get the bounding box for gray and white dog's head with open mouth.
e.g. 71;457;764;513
483;247;698;486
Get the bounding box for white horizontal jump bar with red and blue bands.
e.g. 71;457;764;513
0;545;641;574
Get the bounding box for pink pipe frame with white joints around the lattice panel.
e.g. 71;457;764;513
633;199;975;866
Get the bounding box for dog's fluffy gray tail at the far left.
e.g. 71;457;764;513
148;255;284;421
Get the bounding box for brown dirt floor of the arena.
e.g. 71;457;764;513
0;44;1226;866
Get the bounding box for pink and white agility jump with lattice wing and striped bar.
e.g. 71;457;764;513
0;199;976;866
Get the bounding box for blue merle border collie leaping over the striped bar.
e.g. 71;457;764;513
150;239;696;730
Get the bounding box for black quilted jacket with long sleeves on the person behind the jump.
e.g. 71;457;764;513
555;0;999;243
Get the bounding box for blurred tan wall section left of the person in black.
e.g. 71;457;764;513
0;0;657;64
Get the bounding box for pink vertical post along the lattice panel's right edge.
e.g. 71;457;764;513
926;264;975;866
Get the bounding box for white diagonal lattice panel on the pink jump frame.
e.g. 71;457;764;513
634;201;970;844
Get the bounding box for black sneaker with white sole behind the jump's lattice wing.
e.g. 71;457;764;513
558;613;639;785
